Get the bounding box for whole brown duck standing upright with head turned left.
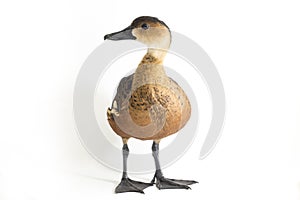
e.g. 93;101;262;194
104;16;197;193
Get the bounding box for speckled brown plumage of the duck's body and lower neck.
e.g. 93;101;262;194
107;53;191;140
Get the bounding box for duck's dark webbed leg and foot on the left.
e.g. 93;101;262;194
115;140;153;193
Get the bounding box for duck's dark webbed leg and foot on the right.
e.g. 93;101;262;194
151;141;198;189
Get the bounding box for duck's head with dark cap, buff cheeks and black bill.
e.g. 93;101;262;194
104;16;171;49
